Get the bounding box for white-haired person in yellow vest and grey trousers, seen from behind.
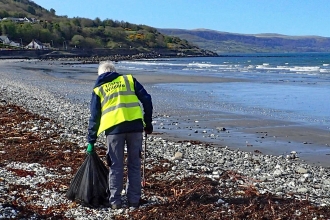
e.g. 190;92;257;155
87;61;153;209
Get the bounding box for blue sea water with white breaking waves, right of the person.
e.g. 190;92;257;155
116;53;330;129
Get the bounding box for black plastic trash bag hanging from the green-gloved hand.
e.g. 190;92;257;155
66;152;109;208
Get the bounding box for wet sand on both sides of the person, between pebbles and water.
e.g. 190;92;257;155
0;61;330;167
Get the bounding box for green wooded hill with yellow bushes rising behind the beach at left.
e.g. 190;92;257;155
0;0;215;56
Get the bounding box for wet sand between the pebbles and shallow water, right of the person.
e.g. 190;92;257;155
156;111;330;167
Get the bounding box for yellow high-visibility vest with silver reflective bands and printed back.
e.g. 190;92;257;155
94;75;143;135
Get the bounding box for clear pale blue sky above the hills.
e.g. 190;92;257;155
32;0;330;37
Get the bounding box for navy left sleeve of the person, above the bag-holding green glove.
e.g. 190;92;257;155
87;92;101;145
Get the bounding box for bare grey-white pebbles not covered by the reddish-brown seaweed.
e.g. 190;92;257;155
0;59;330;219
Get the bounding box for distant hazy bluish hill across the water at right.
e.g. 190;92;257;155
158;29;330;54
